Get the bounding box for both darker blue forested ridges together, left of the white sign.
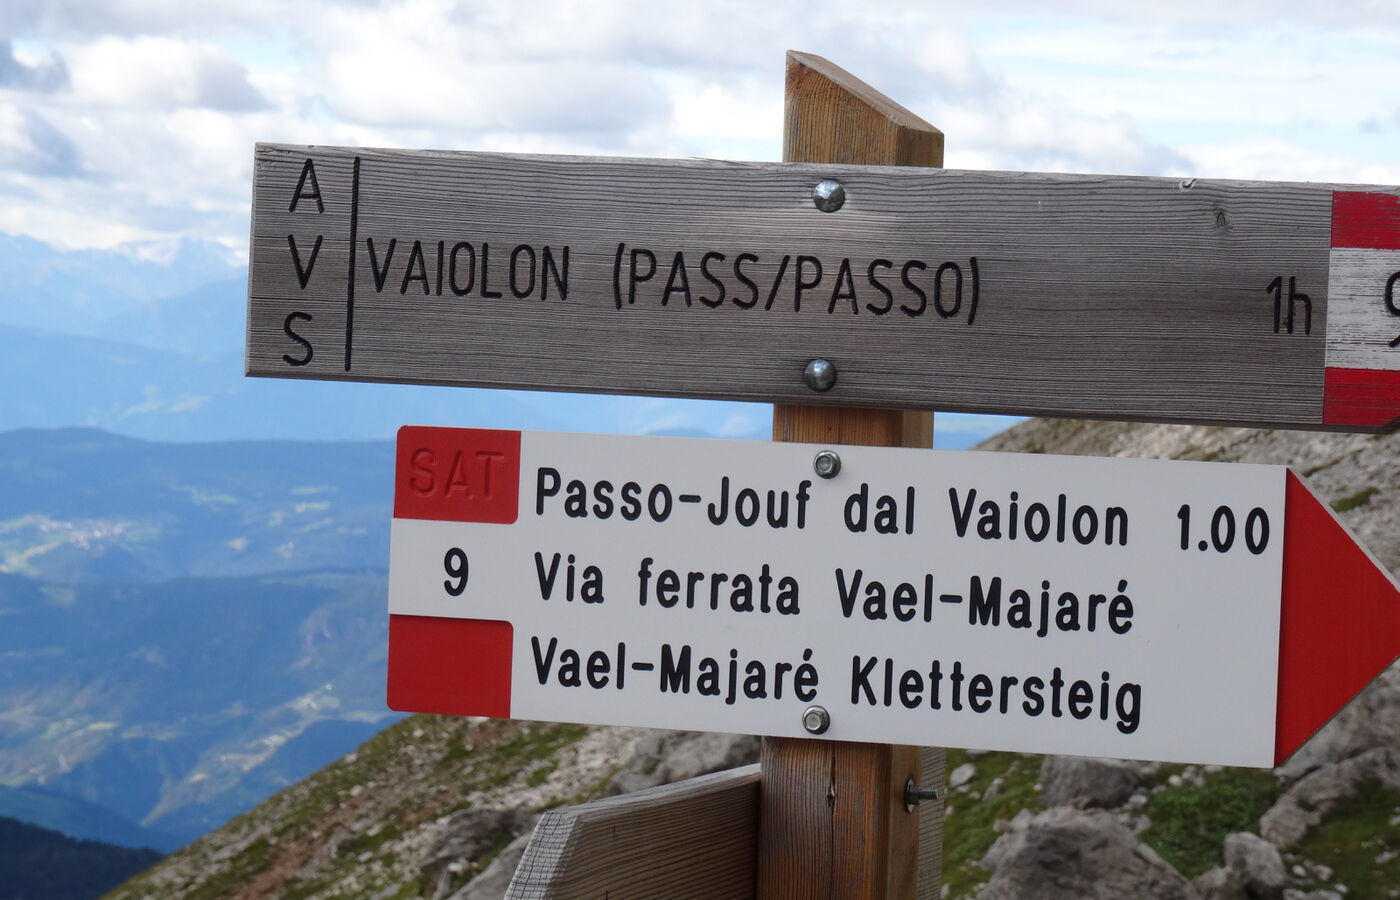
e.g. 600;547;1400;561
0;428;395;850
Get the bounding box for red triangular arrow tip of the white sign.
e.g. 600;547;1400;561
1274;472;1400;766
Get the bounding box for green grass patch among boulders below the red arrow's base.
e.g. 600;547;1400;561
1141;768;1280;878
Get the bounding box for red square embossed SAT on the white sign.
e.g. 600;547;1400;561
393;426;521;525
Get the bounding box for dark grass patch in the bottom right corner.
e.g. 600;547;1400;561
1294;780;1400;897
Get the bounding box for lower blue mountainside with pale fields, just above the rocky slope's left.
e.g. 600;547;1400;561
0;571;395;848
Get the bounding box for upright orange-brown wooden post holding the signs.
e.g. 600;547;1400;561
757;52;944;900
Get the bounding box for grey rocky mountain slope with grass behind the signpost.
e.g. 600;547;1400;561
111;420;1400;900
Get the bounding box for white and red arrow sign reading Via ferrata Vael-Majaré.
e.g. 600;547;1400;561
388;427;1400;766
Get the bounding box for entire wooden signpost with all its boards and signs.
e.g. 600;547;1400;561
248;47;1400;900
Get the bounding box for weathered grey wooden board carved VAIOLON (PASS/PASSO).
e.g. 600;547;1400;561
248;144;1400;431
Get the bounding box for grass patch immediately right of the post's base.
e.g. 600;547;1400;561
944;749;1040;897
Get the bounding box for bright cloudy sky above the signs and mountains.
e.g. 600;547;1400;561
0;0;1400;447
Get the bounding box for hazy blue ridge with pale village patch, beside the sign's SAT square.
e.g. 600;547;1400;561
0;428;393;582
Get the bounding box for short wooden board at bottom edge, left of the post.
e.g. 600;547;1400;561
505;766;759;900
